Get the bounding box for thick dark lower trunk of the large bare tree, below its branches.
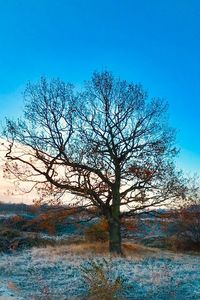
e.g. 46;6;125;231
109;216;122;254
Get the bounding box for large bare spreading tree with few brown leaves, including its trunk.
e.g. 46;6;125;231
4;72;184;253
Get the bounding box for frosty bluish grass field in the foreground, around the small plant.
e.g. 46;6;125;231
0;245;200;300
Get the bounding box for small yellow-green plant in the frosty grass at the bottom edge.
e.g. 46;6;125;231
81;260;124;300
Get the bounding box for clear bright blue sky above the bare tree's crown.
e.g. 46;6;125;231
0;0;200;172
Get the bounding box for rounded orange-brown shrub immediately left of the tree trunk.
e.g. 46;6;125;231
84;218;108;242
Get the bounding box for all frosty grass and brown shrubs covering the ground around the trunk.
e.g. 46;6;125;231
0;203;200;300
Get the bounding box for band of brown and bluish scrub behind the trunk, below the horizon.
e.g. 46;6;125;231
0;205;200;252
